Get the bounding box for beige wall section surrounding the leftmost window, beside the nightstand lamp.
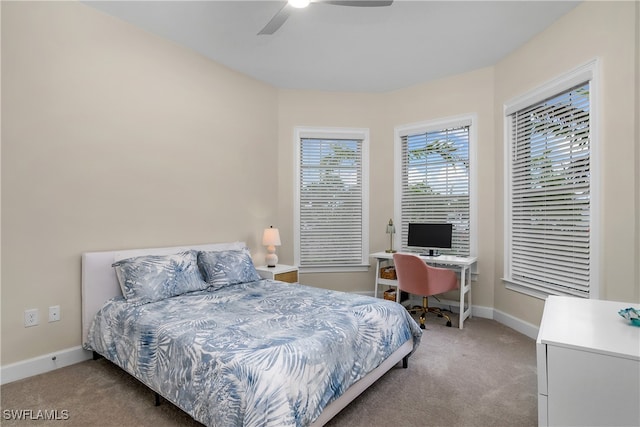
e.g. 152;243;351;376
278;90;393;291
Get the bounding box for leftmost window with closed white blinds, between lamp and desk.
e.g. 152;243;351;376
294;128;369;272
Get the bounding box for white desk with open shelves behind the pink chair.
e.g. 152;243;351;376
369;252;478;329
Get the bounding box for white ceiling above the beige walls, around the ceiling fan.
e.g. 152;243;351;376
84;0;580;92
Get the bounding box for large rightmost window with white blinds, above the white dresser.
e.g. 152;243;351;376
505;63;597;298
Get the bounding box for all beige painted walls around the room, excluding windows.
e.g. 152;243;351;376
1;2;640;365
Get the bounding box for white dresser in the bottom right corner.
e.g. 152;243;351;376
536;296;640;426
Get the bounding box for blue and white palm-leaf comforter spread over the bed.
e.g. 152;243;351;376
85;280;422;427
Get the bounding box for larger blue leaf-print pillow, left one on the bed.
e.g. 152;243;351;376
113;251;209;305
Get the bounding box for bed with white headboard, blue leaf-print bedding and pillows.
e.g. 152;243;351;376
82;242;422;426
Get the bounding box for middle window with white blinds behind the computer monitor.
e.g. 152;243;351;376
395;116;475;256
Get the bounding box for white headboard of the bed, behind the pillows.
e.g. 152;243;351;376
82;242;245;344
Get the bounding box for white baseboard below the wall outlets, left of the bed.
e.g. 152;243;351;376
0;346;93;384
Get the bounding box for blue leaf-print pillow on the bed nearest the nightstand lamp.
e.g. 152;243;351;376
198;248;260;291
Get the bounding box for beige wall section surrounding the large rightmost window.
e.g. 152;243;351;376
495;1;640;325
